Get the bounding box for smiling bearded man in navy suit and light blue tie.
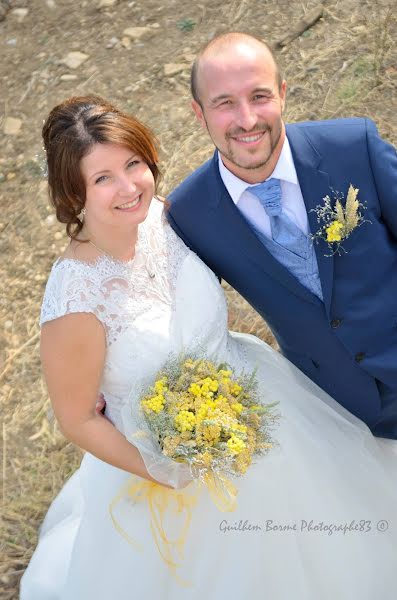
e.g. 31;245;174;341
169;33;397;439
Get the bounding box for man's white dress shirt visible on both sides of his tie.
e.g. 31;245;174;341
218;137;309;237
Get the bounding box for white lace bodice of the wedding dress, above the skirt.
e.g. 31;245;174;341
41;200;228;429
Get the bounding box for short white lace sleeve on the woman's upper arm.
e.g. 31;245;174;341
40;259;105;325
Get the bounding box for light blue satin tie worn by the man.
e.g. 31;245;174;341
251;178;308;258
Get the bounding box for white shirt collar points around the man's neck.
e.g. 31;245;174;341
218;136;298;204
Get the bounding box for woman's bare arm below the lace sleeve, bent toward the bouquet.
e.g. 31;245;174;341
41;313;158;481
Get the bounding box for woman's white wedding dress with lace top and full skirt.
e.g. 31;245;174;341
20;200;397;600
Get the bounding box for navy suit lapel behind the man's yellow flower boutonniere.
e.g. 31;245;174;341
286;125;334;315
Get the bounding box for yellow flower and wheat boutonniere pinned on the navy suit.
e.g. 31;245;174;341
311;184;370;256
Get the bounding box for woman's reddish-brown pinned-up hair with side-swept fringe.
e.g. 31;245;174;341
42;96;160;239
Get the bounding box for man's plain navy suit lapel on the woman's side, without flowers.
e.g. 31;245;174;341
209;154;319;303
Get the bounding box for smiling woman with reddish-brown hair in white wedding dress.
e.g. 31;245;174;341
20;96;397;600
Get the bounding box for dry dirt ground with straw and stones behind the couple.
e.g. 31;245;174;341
0;0;397;600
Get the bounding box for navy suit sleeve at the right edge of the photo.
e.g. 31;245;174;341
366;119;397;239
